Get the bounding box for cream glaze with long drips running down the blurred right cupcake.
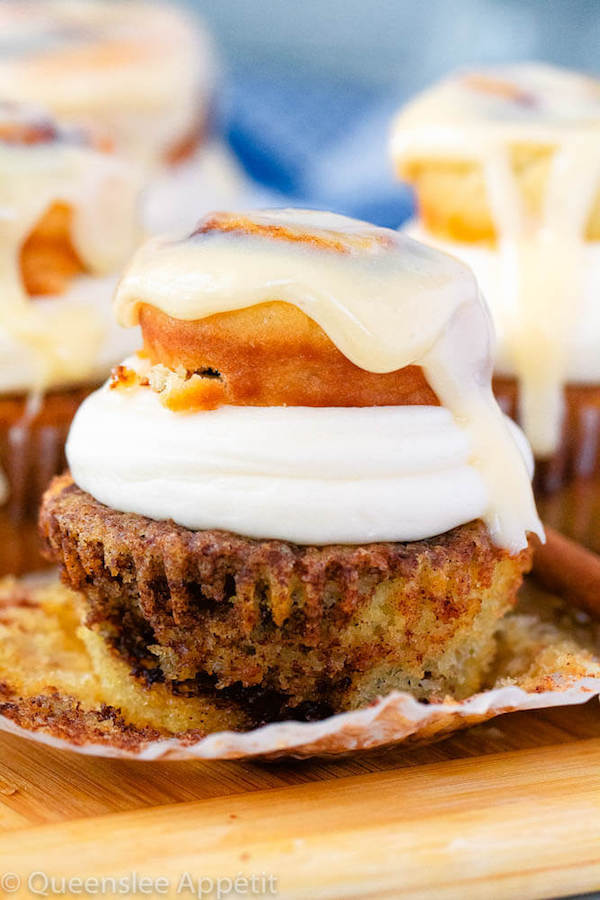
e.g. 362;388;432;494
391;64;600;457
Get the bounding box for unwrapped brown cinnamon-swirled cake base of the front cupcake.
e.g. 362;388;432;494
40;474;531;718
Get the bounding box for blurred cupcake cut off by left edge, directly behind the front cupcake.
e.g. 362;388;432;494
0;104;139;532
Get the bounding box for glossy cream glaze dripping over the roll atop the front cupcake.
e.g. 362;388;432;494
110;210;543;552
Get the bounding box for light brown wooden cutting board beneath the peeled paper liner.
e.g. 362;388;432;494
0;485;600;900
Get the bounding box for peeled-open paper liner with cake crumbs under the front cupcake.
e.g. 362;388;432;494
0;580;600;760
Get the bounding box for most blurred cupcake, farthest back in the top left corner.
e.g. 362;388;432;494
0;0;239;236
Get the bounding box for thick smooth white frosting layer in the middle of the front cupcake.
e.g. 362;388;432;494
67;385;532;544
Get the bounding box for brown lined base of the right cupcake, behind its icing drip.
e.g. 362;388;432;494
493;376;600;494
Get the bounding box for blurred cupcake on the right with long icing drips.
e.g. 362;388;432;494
391;64;600;487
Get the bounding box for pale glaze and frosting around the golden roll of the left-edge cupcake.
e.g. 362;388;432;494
0;106;140;392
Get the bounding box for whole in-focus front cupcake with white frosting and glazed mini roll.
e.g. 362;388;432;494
40;210;542;719
